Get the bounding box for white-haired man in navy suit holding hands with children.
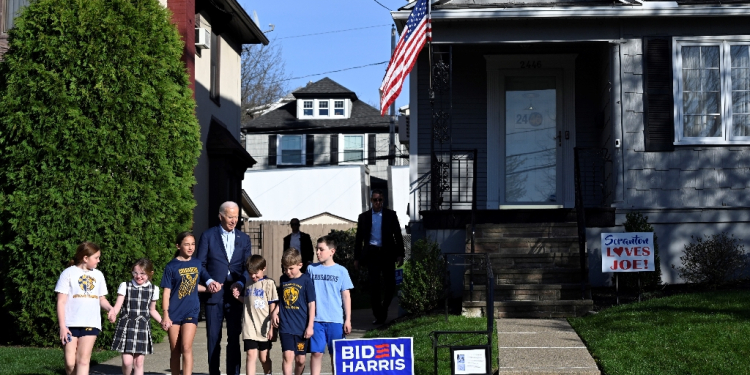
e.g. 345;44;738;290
195;202;251;375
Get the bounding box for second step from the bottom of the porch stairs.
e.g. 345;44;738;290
463;283;588;301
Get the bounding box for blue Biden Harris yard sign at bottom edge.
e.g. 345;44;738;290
333;337;414;375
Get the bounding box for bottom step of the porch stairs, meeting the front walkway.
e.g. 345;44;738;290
462;299;594;318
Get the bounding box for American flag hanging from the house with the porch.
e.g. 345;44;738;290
380;0;432;116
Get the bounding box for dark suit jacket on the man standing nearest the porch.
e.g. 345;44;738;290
354;207;404;264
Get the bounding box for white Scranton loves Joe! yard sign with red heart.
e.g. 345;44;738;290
602;232;656;272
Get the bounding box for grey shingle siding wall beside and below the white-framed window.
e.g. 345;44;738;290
617;39;750;209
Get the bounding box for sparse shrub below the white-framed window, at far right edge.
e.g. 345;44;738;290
672;232;750;288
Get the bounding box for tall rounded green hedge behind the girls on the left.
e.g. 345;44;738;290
0;0;201;346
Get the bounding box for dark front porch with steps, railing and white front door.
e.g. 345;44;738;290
410;42;615;318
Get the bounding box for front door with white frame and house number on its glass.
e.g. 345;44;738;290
487;55;575;209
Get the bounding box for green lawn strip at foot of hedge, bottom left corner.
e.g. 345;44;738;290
0;346;120;375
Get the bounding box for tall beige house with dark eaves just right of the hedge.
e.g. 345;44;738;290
166;0;268;235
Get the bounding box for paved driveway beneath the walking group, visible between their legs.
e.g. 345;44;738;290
90;306;398;375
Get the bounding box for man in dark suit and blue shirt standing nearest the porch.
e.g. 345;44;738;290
354;189;404;324
